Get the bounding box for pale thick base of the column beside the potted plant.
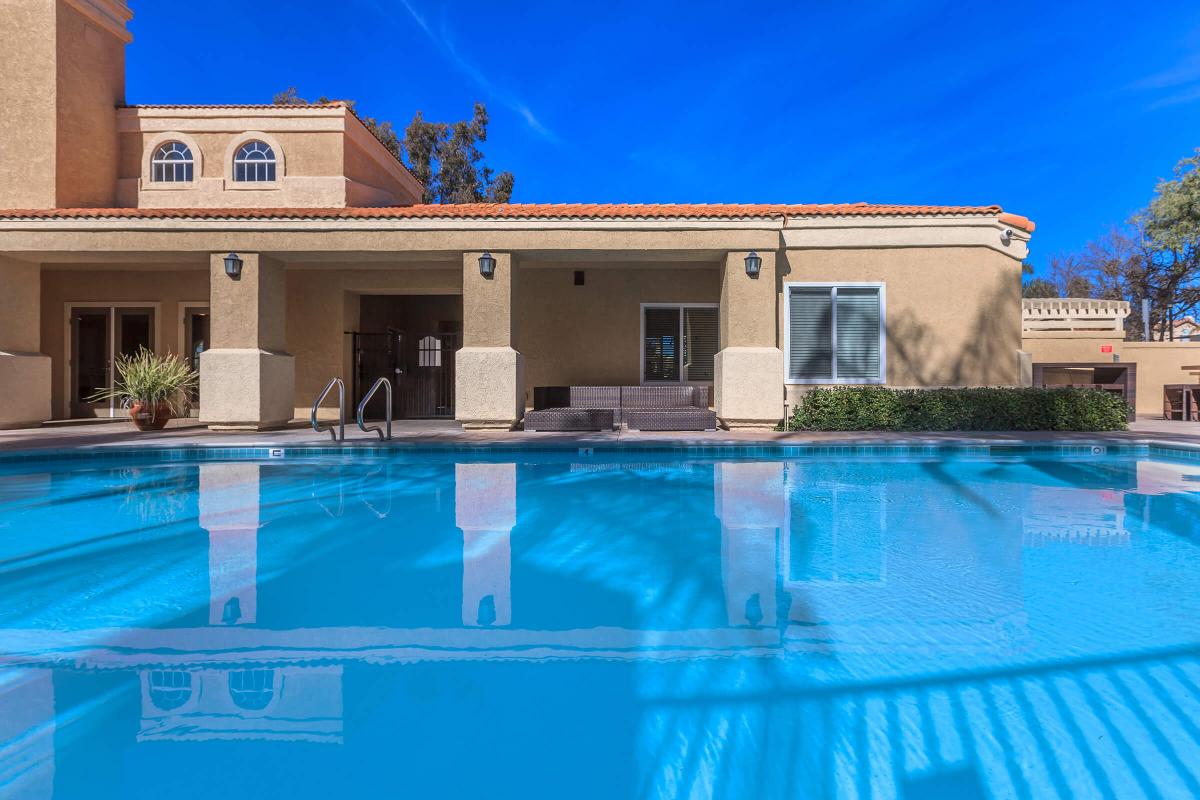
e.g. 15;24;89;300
200;349;295;431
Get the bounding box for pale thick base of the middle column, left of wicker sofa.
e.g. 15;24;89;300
454;347;524;431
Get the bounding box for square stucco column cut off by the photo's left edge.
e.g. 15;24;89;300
0;258;50;428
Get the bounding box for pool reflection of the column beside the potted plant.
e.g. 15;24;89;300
200;464;260;625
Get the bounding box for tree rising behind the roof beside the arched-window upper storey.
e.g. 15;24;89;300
272;86;514;203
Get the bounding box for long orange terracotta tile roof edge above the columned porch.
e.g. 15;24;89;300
0;203;1033;231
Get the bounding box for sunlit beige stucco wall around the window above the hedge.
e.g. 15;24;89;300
779;247;1021;403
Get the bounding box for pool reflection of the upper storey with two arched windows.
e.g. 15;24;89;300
138;664;342;742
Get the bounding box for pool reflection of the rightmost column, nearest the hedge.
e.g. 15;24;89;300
714;462;787;626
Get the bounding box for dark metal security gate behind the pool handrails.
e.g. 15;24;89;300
350;330;461;419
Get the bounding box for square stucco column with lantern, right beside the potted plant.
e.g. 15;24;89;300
200;253;295;431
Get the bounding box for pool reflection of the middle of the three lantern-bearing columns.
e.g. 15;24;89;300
455;464;517;626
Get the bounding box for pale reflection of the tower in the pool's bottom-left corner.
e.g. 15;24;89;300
0;669;55;800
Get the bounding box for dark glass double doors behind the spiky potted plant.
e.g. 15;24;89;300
67;306;155;417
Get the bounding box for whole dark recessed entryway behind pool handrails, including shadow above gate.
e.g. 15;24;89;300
349;295;462;420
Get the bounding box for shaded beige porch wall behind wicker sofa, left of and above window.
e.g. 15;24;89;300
517;261;721;398
